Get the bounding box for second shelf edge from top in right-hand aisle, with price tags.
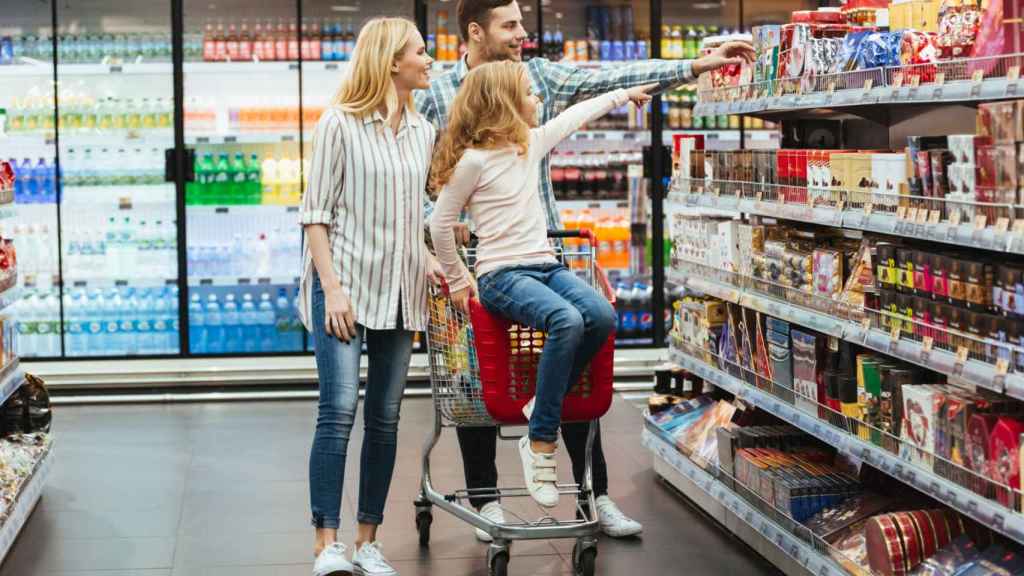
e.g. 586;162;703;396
669;180;1024;254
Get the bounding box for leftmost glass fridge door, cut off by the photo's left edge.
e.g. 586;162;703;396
0;2;60;358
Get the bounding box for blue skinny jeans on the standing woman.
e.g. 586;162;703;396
309;275;413;528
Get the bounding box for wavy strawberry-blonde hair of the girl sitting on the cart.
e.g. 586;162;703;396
430;60;529;196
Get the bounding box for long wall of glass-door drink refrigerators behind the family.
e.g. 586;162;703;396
0;0;737;358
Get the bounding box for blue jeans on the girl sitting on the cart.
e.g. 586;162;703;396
479;264;615;442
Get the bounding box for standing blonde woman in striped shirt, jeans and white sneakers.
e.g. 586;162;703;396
300;18;441;576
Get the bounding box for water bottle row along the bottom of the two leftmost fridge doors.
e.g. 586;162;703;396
14;286;180;358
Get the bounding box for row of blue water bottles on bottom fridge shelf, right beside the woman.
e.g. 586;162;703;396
188;288;303;354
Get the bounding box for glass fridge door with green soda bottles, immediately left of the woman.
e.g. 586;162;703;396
184;0;303;355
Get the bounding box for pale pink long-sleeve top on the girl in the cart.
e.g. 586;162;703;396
430;90;629;291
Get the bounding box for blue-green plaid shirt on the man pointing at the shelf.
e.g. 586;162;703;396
416;56;693;230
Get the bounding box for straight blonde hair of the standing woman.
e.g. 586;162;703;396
332;17;417;119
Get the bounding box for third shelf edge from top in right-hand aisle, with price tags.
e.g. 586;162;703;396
668;263;1024;400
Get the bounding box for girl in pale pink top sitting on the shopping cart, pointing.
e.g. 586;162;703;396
430;61;654;507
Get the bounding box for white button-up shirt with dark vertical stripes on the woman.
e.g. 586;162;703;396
299;108;436;330
